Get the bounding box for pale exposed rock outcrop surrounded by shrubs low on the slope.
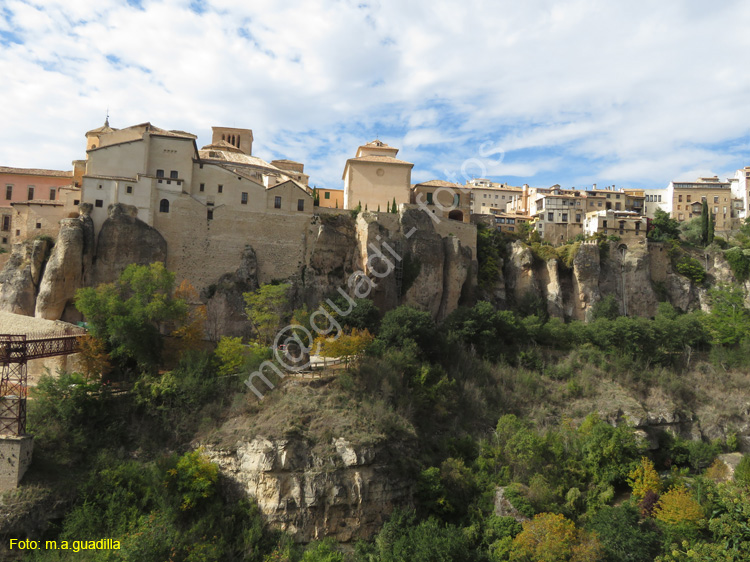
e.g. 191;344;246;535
206;438;413;542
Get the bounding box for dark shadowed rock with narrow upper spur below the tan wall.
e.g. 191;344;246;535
202;246;259;340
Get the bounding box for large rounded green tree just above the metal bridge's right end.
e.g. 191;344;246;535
76;263;188;371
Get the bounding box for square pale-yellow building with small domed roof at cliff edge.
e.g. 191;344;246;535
342;139;414;211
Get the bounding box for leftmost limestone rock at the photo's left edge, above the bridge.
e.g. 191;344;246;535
0;238;52;316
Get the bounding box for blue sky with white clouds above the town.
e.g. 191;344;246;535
0;0;750;189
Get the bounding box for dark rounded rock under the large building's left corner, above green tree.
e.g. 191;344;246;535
91;203;167;286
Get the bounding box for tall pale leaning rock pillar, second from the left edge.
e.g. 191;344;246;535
36;215;94;320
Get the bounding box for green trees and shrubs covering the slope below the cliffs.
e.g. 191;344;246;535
4;260;750;562
